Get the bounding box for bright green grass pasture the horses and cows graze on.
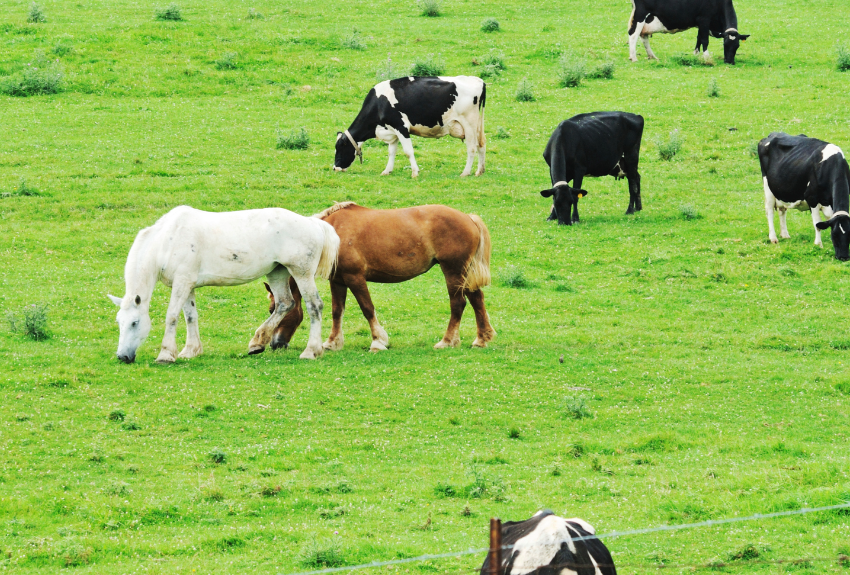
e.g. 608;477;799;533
0;0;850;575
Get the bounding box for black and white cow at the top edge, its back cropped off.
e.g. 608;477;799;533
629;0;750;64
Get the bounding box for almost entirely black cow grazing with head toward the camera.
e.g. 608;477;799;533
540;112;643;226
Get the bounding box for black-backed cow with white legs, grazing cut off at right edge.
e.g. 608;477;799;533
759;132;850;261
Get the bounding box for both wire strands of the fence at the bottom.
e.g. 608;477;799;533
274;502;850;575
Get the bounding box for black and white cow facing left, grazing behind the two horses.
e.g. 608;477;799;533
334;76;487;178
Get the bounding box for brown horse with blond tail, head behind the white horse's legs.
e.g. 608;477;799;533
252;202;496;353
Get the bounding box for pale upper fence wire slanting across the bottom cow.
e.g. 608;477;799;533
278;503;850;575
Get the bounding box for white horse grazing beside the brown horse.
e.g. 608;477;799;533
109;206;339;363
